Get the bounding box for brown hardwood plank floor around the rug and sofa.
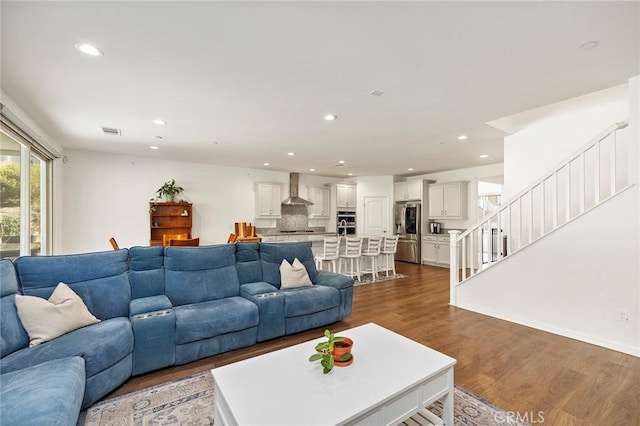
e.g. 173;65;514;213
107;262;640;425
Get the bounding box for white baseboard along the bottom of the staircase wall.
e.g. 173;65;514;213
456;304;640;357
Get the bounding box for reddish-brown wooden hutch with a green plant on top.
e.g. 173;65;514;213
149;202;193;246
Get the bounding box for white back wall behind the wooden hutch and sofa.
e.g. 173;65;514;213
62;150;344;254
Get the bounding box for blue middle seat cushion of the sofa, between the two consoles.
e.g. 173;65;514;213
174;297;258;345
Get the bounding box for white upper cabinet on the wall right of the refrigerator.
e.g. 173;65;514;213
429;182;467;219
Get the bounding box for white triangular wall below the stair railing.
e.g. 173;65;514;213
457;186;640;356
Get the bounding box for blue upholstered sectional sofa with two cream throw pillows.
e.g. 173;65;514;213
0;243;353;425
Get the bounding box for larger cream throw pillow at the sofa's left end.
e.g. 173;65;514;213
16;283;100;347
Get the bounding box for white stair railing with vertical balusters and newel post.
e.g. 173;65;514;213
449;122;629;305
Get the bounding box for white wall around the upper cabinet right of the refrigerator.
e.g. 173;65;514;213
412;163;504;229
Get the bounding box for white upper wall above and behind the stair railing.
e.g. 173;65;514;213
496;84;629;199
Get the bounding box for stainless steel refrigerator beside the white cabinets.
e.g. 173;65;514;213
394;203;422;263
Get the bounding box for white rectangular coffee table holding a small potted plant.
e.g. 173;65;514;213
211;323;456;426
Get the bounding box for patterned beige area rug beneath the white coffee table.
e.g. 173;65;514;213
78;371;528;426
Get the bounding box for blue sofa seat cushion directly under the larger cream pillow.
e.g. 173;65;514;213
0;318;133;377
